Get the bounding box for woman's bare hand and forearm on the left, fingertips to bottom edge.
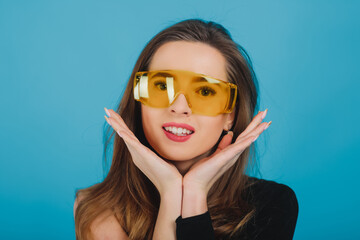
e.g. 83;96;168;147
105;108;183;239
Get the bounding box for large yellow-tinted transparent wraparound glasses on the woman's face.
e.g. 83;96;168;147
134;70;237;116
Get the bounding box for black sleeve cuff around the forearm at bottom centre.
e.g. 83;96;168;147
176;211;215;240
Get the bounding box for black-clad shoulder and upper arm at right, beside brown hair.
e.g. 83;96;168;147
236;177;299;239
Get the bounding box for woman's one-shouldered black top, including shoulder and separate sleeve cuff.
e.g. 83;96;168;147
176;177;299;240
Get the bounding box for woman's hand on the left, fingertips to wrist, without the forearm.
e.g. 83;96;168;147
105;108;182;196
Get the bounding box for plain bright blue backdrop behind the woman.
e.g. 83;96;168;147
0;0;360;239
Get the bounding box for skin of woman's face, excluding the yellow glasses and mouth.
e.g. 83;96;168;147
141;41;232;167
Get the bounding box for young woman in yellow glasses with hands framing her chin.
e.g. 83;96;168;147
74;19;298;240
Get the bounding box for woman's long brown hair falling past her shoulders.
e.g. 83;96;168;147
75;19;258;239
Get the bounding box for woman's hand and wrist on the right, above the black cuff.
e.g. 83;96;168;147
182;110;271;217
